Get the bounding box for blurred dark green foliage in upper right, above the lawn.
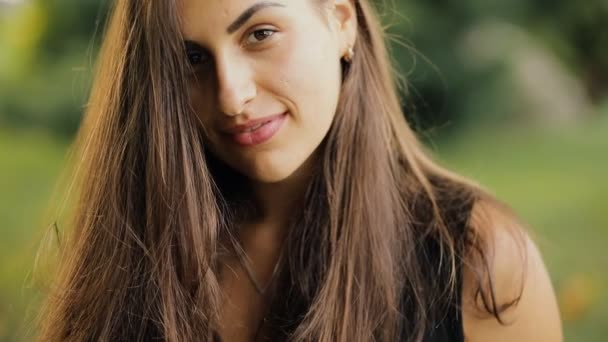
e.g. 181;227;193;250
382;0;608;137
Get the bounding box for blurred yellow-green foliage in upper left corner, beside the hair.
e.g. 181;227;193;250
0;0;108;138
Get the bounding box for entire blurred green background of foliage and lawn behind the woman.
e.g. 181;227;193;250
0;0;608;342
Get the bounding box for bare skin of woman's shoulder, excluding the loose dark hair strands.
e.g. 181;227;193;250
462;201;563;342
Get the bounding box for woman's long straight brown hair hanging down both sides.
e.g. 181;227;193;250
39;0;524;341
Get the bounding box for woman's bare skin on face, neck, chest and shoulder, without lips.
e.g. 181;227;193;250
181;0;562;342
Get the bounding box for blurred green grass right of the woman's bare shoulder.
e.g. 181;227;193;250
435;116;608;342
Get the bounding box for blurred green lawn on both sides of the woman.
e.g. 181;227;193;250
0;116;608;342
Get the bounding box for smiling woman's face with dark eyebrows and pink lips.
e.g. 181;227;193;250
181;0;356;183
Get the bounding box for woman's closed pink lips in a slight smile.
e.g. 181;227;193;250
224;113;287;146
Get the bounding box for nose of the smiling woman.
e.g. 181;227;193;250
216;51;256;116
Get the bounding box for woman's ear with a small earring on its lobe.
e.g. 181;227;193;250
330;0;357;54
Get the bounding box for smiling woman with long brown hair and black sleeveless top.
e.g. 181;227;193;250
40;0;561;341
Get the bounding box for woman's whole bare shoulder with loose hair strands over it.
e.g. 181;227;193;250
462;199;563;342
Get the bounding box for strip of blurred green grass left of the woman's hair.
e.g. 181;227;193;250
0;130;66;341
